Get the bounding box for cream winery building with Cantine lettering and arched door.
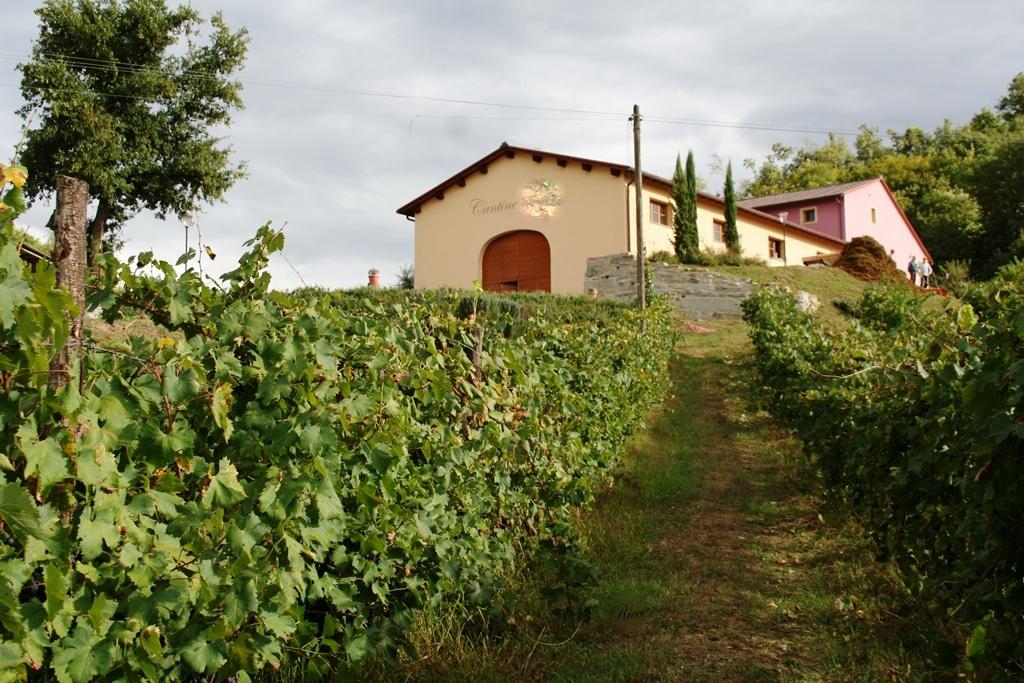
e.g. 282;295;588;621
398;144;845;294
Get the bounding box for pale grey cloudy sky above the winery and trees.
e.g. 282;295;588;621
0;0;1024;289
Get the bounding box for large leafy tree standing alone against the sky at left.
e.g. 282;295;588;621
18;0;248;264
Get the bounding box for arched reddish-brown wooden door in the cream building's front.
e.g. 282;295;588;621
483;230;551;292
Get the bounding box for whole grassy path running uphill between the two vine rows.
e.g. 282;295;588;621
374;323;959;683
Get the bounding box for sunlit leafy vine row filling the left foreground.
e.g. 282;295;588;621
0;175;673;683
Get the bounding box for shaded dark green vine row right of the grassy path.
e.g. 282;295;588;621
743;276;1024;675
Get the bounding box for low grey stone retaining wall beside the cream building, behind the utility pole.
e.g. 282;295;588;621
584;254;754;319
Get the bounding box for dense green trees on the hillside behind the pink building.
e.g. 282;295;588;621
740;73;1024;275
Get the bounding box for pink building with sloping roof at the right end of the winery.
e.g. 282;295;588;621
737;178;931;269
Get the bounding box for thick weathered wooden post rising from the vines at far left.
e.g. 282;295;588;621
49;175;89;389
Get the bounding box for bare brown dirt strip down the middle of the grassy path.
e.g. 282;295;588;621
647;344;823;681
